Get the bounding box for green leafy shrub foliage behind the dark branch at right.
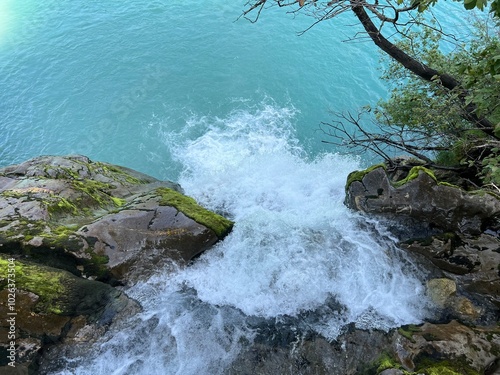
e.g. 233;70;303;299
374;15;500;186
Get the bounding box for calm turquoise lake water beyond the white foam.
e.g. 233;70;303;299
0;0;385;179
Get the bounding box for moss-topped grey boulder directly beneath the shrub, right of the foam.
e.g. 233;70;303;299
345;166;500;234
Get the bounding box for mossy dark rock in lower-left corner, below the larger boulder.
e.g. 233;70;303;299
0;254;139;373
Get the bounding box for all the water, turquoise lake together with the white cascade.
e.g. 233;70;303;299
0;0;476;375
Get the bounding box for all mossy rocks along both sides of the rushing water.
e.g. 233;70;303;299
0;155;500;375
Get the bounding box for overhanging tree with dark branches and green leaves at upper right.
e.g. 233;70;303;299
244;0;500;190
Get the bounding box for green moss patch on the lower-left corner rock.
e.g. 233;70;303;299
0;257;65;314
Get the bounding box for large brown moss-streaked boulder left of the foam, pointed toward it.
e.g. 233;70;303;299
0;155;233;283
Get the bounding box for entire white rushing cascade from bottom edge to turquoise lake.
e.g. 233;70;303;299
48;105;426;375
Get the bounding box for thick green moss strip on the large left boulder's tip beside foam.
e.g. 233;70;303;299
156;188;234;238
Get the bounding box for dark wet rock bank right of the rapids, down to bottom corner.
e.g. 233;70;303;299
345;166;500;375
